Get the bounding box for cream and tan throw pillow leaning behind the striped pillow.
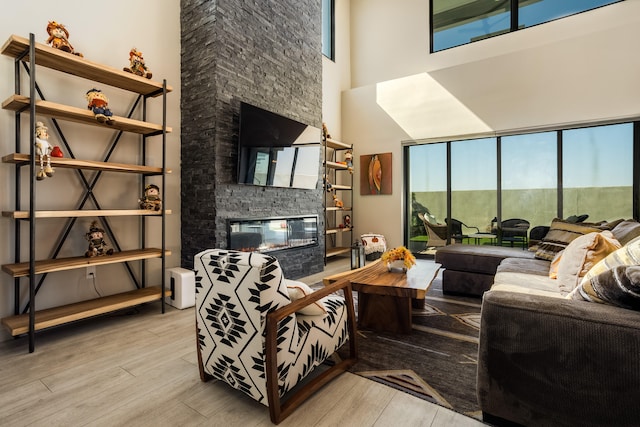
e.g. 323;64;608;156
558;230;621;293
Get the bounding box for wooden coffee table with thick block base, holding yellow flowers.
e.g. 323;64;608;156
323;260;440;334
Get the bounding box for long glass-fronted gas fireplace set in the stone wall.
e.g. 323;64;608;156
228;215;318;253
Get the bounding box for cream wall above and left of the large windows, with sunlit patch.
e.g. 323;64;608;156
342;0;640;246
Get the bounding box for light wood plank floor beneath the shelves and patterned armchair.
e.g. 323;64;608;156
0;260;484;427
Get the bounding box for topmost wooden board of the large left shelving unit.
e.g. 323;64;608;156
2;35;173;96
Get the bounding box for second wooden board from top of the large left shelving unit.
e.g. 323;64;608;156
2;94;172;135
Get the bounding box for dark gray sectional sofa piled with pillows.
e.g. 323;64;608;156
436;220;640;426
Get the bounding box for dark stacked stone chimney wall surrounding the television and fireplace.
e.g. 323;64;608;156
180;0;324;278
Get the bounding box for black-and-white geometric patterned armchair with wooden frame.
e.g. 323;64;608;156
194;249;357;424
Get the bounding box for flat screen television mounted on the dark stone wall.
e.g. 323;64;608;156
238;102;322;189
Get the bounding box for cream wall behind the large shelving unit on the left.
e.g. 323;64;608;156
0;0;180;339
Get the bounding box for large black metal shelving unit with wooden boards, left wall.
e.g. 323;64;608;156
0;34;172;352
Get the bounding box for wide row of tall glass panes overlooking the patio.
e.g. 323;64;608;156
404;123;640;250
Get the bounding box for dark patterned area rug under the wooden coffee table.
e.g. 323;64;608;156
330;275;481;419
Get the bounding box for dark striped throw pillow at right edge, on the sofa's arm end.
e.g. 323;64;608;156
567;265;640;310
